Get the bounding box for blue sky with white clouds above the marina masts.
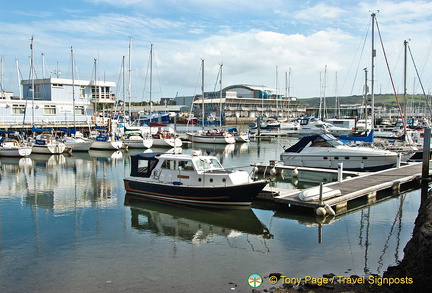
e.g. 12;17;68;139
0;0;432;101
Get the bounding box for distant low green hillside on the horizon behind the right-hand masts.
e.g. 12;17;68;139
299;94;425;108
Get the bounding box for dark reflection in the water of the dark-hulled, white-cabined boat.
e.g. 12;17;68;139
125;193;273;244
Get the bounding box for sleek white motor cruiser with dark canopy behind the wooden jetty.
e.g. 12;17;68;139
280;133;398;171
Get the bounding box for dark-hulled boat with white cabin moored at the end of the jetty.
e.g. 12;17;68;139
124;153;267;206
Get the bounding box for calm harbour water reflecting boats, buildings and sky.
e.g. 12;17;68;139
0;133;420;292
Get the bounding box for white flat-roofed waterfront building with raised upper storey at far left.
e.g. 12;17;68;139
0;78;116;128
